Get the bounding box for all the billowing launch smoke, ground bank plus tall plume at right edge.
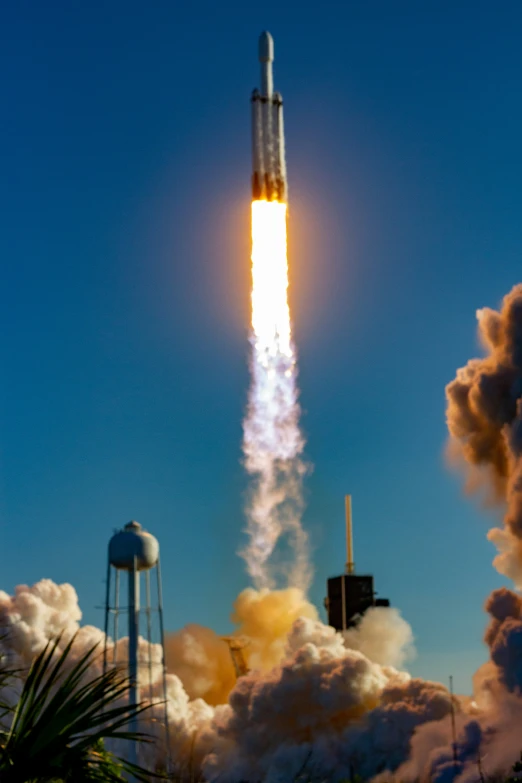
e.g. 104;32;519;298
5;287;522;783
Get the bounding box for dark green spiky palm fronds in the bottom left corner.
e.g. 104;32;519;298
0;638;161;783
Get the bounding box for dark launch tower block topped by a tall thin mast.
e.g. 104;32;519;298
324;495;390;631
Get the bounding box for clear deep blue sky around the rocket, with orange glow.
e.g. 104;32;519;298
0;0;522;690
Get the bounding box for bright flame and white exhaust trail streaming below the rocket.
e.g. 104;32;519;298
241;201;311;590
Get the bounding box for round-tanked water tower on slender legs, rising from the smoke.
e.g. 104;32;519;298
103;521;170;768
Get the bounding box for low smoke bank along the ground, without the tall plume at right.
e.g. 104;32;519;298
7;579;522;783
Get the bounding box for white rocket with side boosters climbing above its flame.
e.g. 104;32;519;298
252;32;287;201
